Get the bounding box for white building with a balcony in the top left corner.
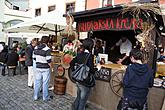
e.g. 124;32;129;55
0;0;31;42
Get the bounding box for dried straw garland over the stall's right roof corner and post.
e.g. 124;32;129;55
122;3;161;62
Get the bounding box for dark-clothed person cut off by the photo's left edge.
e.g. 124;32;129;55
0;45;8;76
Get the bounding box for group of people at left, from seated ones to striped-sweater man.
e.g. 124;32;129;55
0;36;52;101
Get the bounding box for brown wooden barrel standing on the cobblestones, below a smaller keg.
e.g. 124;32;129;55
54;76;67;95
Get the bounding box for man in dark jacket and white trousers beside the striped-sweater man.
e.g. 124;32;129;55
25;39;37;88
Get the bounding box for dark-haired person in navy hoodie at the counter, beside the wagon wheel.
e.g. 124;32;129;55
118;49;154;110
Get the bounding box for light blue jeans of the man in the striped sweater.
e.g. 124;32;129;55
33;68;50;101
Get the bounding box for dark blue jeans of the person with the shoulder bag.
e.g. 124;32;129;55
72;84;91;110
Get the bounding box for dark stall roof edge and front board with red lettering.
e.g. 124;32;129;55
69;5;164;32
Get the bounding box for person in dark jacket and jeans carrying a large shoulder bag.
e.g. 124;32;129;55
70;38;96;110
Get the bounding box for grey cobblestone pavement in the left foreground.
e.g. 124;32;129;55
0;74;100;110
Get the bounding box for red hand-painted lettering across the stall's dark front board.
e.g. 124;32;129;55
77;17;143;32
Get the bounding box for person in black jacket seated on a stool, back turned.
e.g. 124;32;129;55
6;48;19;76
